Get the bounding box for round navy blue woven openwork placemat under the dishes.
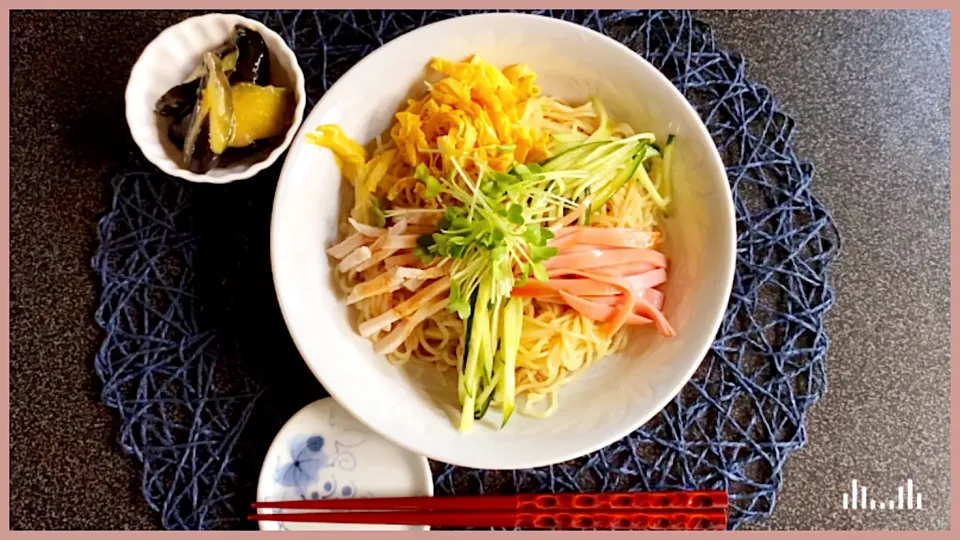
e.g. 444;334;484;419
93;11;839;529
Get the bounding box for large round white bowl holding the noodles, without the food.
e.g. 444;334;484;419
271;14;736;469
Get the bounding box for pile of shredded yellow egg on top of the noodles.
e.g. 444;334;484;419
308;56;550;223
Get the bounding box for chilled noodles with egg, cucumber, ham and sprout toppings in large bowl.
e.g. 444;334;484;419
307;56;674;431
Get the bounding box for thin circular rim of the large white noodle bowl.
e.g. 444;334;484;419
270;12;737;470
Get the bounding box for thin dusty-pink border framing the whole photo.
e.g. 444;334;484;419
0;0;960;539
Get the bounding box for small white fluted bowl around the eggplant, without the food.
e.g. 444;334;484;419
125;13;306;184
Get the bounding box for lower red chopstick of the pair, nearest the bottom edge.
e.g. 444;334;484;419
250;509;727;530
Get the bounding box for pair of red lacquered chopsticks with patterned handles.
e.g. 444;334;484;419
249;491;728;530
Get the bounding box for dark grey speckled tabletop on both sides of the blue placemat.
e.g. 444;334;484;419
10;11;950;529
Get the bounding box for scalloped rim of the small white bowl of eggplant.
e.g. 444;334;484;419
123;13;307;184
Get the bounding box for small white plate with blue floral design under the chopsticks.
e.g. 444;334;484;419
257;398;433;531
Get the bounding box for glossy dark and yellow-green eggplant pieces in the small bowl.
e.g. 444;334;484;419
155;25;296;174
